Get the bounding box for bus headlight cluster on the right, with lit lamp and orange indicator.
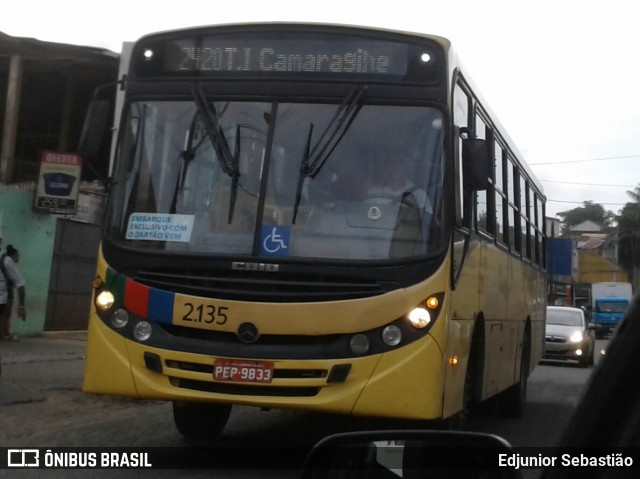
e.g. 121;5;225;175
349;295;442;356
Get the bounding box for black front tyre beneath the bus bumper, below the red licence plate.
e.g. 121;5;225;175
173;401;231;439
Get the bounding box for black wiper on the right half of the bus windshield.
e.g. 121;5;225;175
292;86;367;224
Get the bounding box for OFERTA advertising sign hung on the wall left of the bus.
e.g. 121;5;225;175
35;151;82;215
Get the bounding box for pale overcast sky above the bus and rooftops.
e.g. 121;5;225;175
0;0;640;217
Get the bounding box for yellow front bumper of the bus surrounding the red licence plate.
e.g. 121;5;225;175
83;316;444;419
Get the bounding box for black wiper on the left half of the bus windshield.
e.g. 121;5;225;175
192;85;240;224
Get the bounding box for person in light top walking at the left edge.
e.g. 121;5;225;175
0;245;27;341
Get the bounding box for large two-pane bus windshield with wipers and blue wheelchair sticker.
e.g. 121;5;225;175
107;99;444;260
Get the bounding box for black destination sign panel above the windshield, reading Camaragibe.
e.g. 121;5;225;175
130;25;445;84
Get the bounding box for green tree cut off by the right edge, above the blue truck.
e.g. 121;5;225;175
616;185;640;284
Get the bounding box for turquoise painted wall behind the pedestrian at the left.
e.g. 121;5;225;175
0;185;56;336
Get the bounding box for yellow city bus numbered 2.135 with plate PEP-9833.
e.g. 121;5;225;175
83;23;546;437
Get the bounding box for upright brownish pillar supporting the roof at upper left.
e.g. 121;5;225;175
0;55;22;184
